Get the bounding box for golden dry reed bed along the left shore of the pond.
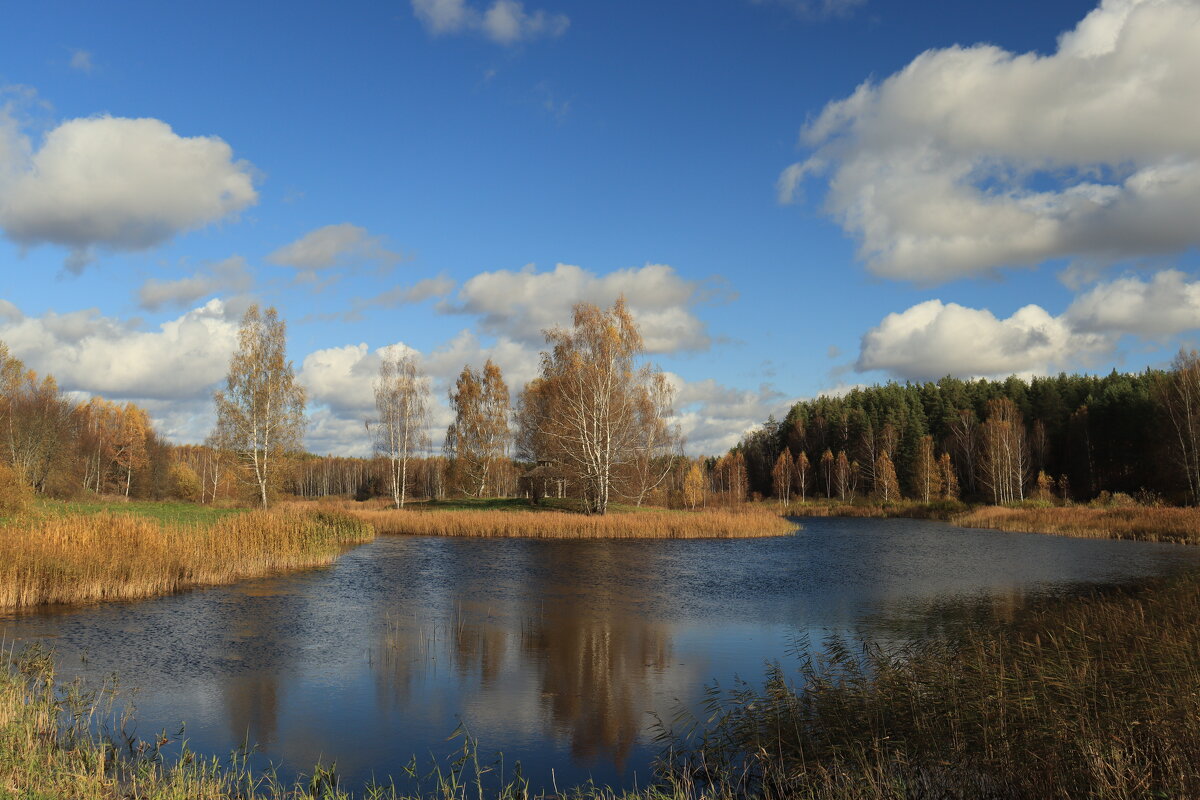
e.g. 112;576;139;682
0;511;374;609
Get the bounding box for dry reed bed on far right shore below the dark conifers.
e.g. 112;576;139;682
950;506;1200;545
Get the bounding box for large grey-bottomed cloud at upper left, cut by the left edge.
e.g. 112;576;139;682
0;115;258;272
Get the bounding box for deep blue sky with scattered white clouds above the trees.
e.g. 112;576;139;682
0;0;1200;453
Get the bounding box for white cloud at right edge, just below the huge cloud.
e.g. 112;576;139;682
1064;270;1200;337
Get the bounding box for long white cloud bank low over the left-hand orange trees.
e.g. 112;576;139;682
0;300;238;401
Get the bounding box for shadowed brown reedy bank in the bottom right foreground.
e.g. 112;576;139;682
677;566;1200;800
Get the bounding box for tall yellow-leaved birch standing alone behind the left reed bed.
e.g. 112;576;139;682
214;305;305;507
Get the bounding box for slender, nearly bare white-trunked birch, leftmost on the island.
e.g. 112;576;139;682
374;348;430;509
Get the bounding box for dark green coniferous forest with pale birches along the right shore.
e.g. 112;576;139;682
732;353;1200;503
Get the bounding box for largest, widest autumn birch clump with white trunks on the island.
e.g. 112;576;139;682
518;299;665;513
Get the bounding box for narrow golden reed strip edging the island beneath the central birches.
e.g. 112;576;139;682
352;509;798;539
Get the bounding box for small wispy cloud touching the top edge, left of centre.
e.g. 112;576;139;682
412;0;571;46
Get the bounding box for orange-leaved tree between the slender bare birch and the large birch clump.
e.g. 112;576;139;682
445;359;509;497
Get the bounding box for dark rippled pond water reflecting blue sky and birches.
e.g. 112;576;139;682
0;519;1200;788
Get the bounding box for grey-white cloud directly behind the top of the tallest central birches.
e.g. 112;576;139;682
443;264;712;353
